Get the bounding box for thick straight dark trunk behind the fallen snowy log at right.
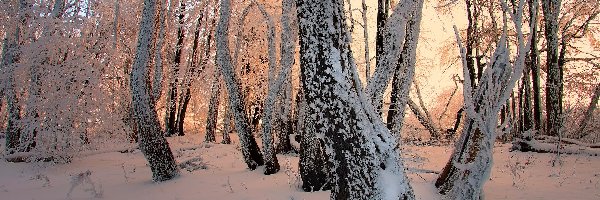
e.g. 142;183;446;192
542;0;563;136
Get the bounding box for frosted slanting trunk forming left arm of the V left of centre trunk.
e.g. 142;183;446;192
215;0;264;170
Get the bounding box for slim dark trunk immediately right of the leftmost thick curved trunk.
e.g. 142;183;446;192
165;0;185;136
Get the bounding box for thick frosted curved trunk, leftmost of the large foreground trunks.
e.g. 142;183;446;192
131;0;179;182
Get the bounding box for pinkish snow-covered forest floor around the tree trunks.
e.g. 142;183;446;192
0;135;600;200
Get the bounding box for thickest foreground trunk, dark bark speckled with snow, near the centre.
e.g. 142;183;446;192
297;0;414;200
